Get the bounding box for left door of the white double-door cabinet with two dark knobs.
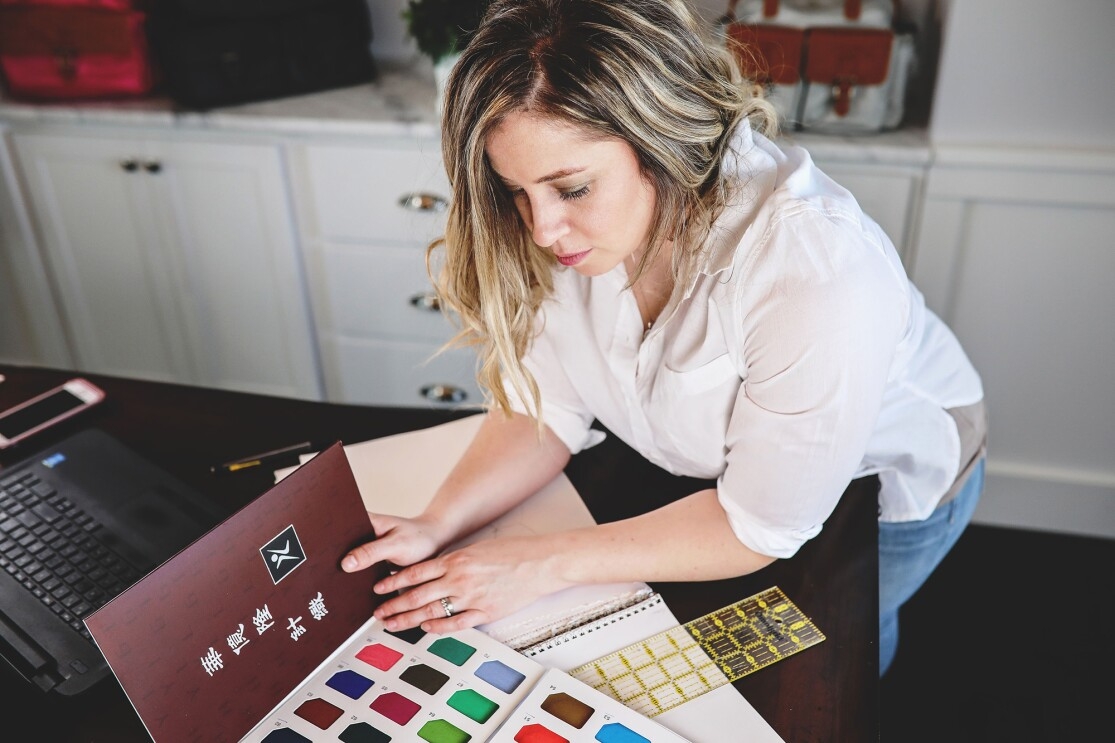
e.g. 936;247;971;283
13;133;193;382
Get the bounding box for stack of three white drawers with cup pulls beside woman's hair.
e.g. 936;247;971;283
293;137;482;406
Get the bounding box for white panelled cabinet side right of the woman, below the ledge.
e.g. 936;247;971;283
913;147;1115;538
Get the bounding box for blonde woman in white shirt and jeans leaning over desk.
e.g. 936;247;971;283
342;0;985;669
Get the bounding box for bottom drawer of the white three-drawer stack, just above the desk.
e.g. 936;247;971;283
323;337;483;407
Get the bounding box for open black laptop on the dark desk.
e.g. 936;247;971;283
0;428;226;696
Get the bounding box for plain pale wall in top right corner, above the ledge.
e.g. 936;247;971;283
930;0;1115;148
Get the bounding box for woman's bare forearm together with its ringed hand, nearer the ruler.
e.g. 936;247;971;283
365;490;773;631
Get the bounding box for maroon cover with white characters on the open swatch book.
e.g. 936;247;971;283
86;443;386;743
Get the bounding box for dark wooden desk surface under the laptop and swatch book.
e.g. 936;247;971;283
0;365;879;743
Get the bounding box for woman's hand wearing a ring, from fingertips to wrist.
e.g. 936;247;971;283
374;537;568;633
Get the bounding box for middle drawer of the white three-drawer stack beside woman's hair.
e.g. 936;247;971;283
321;239;453;342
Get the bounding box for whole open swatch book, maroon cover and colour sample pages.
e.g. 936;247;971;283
86;444;685;743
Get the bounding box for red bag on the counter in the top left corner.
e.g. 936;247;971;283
0;0;155;100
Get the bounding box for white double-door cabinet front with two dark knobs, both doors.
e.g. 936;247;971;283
11;127;321;398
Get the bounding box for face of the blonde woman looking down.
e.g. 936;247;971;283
485;112;655;276
